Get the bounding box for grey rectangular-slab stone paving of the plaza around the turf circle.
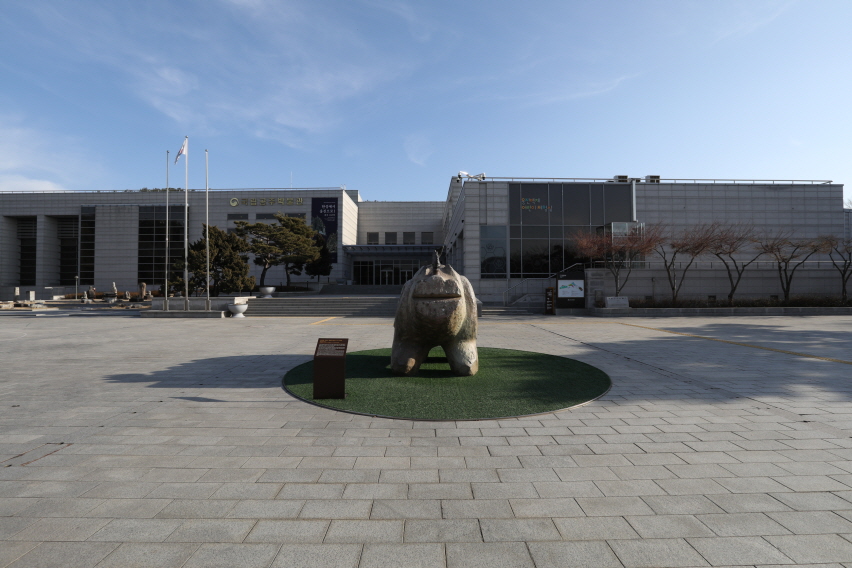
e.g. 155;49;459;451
0;314;852;568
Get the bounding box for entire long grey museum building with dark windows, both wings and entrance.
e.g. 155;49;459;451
0;175;850;303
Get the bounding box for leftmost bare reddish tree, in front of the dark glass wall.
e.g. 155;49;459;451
572;227;659;296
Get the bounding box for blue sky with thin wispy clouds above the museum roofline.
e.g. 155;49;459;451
0;0;852;204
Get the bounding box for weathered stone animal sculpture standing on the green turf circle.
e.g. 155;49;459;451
391;252;479;376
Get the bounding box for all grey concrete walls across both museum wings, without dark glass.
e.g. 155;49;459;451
0;177;852;303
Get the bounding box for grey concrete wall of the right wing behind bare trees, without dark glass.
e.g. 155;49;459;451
443;178;850;303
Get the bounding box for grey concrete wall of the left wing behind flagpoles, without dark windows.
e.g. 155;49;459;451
0;188;358;296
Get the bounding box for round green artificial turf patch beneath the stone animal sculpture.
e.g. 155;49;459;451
283;347;611;420
